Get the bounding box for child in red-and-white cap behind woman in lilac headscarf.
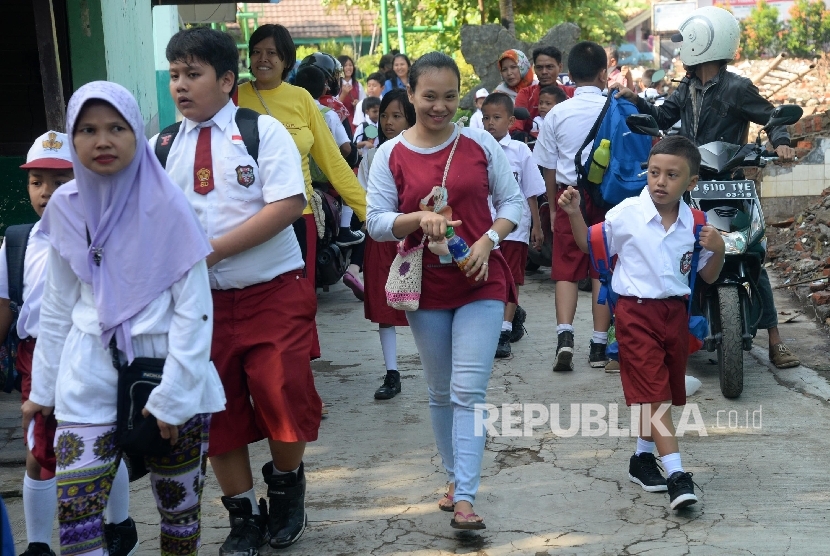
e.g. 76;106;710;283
0;131;138;556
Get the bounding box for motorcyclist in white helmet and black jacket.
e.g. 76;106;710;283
612;6;800;369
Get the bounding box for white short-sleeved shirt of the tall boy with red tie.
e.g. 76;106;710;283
150;101;308;290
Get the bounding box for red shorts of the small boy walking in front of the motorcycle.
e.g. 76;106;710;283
615;296;689;405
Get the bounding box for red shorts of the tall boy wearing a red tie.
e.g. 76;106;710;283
208;270;323;456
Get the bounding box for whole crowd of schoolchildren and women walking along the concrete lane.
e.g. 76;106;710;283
0;6;798;556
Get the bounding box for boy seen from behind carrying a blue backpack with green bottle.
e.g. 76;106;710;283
533;41;611;372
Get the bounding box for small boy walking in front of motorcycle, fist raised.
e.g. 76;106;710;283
559;136;725;510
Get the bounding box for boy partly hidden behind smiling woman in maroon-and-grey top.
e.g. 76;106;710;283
481;92;545;358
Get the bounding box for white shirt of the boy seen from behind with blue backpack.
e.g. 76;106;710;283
533;87;605;185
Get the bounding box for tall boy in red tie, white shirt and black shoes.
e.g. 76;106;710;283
156;28;322;555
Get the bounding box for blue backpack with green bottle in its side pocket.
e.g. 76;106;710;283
575;91;651;209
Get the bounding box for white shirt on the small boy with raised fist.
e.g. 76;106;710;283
603;187;713;299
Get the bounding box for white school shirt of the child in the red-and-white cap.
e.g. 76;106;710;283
0;222;49;339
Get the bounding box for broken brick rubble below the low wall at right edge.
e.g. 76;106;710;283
767;189;830;325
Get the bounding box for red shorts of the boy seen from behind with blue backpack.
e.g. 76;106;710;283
550;185;606;282
